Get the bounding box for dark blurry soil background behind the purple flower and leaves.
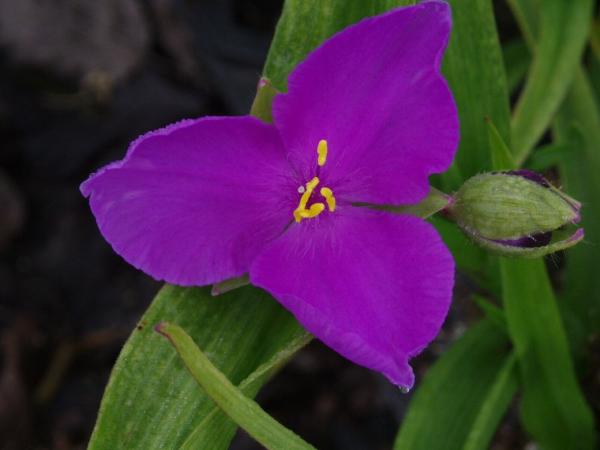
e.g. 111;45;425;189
0;0;522;450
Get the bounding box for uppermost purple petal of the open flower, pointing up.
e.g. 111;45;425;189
273;1;459;204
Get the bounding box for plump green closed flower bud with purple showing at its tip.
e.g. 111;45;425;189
446;170;583;257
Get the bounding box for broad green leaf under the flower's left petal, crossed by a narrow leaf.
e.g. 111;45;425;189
89;286;307;450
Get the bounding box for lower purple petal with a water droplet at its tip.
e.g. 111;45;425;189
250;207;454;388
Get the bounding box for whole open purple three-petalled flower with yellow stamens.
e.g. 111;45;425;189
81;1;458;388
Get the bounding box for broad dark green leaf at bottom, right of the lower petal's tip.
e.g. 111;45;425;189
394;320;516;450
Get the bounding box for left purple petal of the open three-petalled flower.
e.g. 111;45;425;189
81;117;297;285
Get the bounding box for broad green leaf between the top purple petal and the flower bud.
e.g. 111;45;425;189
443;0;510;185
